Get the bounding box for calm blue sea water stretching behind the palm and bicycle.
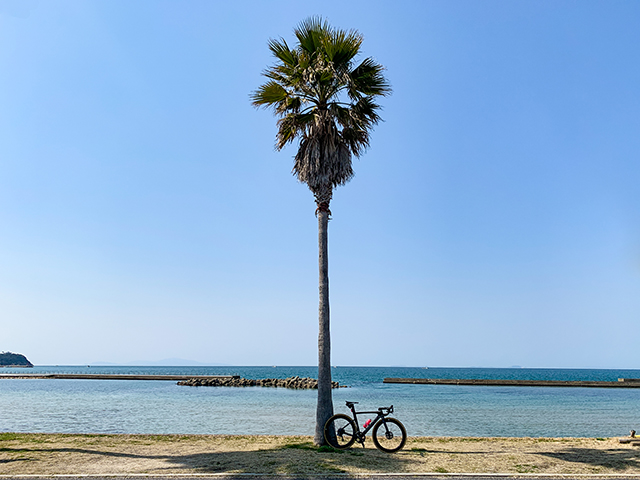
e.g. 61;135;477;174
0;366;640;437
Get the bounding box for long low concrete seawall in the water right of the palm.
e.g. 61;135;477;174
383;378;640;388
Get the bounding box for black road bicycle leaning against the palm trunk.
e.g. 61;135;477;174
324;402;407;453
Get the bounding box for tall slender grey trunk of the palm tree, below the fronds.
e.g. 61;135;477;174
313;208;333;445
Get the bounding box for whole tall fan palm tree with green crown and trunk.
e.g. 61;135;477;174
251;17;391;445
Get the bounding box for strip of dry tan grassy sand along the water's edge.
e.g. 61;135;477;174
0;433;640;475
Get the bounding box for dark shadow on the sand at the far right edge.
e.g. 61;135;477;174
538;447;640;471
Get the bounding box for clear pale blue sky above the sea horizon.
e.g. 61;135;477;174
0;0;640;368
